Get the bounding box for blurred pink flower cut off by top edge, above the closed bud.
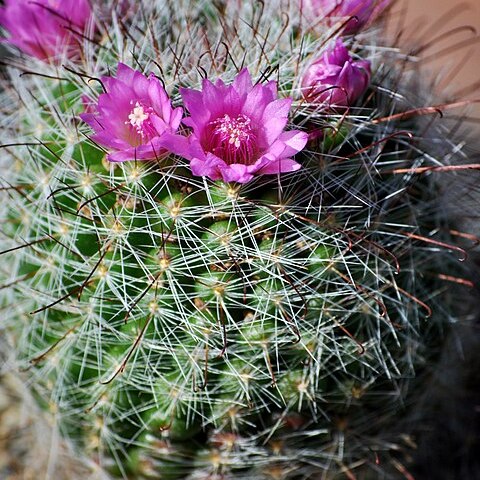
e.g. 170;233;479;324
310;0;391;34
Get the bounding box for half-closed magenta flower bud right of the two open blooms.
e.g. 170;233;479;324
302;39;370;107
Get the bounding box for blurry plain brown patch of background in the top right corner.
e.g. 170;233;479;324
392;0;480;114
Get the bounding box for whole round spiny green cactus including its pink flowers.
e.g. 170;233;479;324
0;0;474;480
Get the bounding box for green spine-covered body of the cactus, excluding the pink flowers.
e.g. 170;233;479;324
0;1;474;480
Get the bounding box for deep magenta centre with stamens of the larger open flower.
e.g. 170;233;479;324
210;114;255;165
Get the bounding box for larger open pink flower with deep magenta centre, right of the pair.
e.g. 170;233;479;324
170;69;308;183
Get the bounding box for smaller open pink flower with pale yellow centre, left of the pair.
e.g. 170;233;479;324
80;63;183;162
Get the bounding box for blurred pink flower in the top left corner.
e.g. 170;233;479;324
0;0;92;60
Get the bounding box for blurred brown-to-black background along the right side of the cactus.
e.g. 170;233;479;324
398;0;480;480
